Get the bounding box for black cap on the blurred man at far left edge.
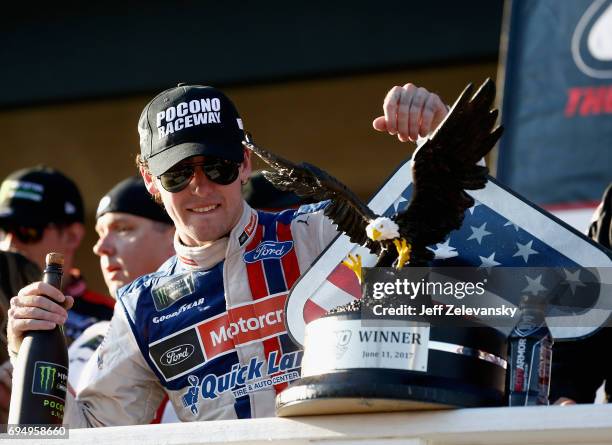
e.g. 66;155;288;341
0;165;85;228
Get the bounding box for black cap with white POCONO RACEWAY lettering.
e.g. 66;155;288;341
138;84;244;176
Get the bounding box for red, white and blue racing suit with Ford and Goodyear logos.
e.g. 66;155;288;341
64;203;337;427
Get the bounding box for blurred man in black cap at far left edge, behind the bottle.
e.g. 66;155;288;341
0;166;114;342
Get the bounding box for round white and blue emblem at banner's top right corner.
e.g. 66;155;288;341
572;0;612;79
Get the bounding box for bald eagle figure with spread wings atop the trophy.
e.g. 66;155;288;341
244;79;502;281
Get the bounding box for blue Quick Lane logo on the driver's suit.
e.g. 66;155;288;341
182;351;303;416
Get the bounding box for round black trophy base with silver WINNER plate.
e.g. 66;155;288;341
276;312;506;416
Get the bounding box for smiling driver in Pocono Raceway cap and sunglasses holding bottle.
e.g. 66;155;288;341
8;84;447;427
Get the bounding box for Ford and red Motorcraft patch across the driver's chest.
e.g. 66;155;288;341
149;293;287;381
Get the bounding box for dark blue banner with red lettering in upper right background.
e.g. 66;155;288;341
497;0;612;230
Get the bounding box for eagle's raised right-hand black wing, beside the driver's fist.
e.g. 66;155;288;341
394;79;502;253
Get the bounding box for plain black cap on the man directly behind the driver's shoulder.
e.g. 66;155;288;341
96;176;173;224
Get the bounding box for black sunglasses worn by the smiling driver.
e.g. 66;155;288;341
157;157;240;193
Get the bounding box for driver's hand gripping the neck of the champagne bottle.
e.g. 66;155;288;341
7;281;74;358
